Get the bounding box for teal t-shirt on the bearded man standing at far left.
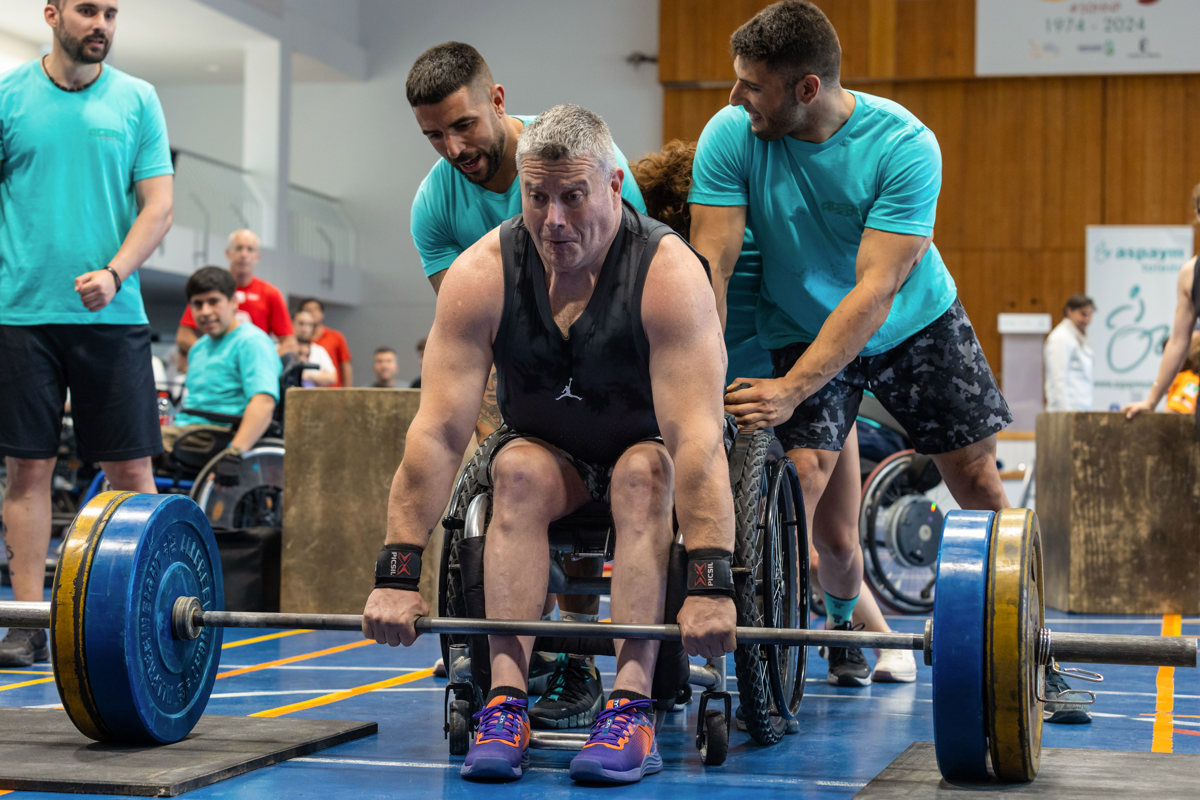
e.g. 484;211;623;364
0;61;173;325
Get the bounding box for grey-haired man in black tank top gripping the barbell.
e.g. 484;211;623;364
362;106;736;783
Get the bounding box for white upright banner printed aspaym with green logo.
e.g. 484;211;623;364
1087;225;1192;411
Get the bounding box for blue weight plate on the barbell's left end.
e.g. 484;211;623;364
83;494;224;744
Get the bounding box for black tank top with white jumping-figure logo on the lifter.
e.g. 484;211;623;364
494;204;707;464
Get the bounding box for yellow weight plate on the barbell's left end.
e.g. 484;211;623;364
50;492;134;741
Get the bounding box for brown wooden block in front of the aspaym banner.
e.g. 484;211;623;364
1037;413;1200;614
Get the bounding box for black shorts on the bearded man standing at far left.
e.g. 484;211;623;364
0;325;162;462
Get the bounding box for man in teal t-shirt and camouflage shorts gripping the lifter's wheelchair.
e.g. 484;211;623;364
689;0;1036;705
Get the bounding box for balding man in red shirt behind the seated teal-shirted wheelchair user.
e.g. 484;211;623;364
175;229;296;369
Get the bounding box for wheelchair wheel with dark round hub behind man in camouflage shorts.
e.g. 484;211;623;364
858;450;949;614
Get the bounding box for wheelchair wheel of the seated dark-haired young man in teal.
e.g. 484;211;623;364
191;439;283;529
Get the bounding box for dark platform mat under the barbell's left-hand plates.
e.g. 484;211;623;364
0;709;378;798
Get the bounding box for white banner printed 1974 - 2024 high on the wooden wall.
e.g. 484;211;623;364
976;0;1200;77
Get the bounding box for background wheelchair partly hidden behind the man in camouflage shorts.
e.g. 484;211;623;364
858;396;954;614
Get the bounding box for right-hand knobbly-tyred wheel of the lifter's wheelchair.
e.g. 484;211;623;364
730;432;809;745
